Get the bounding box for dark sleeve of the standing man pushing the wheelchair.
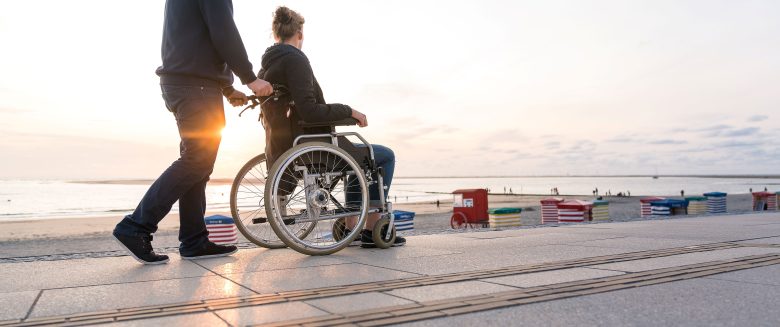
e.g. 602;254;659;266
200;0;257;84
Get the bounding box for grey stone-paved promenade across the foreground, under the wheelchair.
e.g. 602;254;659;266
0;213;780;326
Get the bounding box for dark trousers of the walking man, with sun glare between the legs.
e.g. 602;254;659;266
114;85;225;250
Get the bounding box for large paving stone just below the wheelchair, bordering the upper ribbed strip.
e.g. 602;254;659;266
227;264;417;294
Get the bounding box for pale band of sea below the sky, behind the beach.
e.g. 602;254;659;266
0;176;780;221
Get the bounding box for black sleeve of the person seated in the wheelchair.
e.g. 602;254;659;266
285;56;352;123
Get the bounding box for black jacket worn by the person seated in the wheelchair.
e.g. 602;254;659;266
257;44;352;167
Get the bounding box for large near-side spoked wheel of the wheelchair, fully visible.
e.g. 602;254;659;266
265;142;368;255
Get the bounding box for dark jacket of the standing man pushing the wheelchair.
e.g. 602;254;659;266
157;0;257;93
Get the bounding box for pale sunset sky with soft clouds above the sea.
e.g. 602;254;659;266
0;0;780;179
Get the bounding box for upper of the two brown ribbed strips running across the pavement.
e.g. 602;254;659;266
0;243;756;325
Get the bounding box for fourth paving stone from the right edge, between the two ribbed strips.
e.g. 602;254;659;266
306;292;412;313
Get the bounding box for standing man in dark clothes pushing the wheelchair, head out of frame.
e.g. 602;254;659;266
113;0;273;264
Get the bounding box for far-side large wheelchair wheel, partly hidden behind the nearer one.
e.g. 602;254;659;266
230;154;314;249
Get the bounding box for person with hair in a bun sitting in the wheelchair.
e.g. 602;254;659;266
258;6;402;248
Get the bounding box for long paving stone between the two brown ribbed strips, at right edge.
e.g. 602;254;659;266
591;248;780;272
